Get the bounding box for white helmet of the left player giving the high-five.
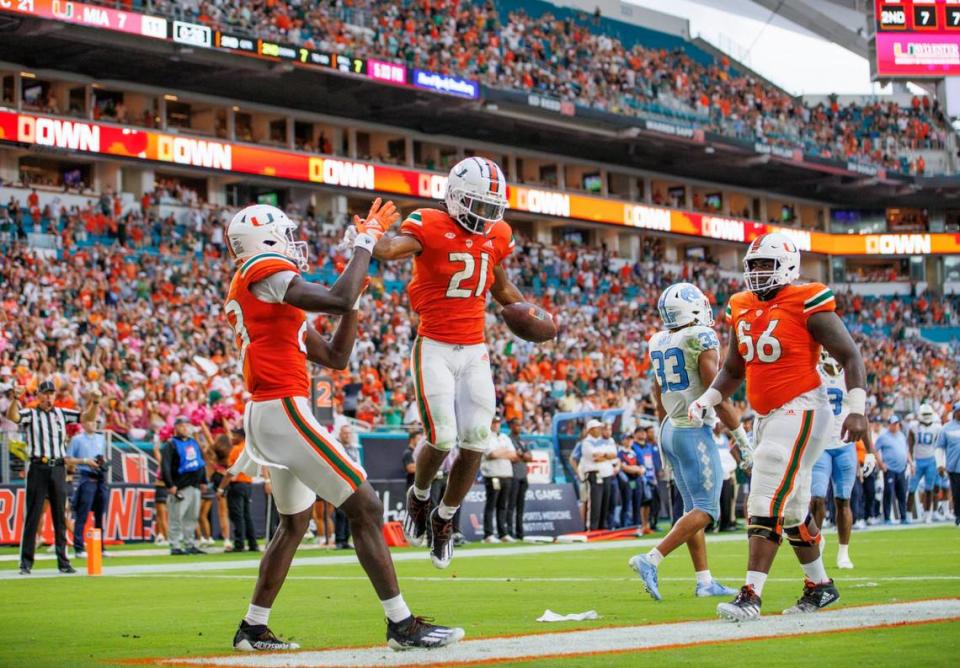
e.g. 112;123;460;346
227;204;307;271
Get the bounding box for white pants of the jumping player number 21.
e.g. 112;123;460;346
412;336;497;452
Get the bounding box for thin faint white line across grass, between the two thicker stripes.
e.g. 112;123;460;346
116;573;960;585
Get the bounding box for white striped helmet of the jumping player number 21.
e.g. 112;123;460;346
444;156;507;234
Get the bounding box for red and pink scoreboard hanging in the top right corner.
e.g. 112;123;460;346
874;0;960;78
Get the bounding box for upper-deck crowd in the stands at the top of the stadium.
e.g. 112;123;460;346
106;0;949;174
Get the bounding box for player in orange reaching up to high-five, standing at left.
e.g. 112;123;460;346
224;199;463;651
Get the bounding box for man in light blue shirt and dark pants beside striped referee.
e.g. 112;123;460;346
66;420;110;557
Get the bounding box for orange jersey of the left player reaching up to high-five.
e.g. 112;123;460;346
224;253;310;401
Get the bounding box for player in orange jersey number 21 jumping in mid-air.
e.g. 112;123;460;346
373;157;523;568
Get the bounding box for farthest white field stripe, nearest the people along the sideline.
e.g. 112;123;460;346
0;524;944;581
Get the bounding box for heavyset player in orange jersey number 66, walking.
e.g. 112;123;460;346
688;233;867;621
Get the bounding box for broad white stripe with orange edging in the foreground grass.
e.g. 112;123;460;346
159;599;960;667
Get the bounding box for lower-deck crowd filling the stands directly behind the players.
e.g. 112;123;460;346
0;193;960;448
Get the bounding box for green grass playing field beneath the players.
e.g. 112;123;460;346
0;526;960;668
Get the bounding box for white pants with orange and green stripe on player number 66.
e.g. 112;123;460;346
747;388;833;527
